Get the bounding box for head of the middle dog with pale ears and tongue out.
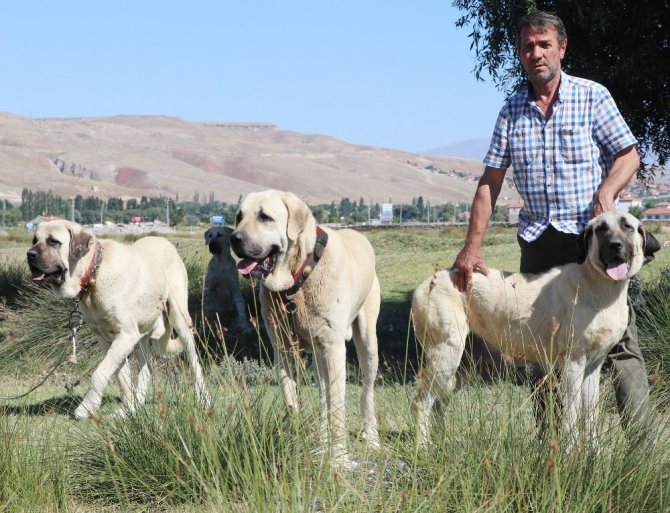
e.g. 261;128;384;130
230;190;316;291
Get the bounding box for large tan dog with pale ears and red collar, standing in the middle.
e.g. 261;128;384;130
231;190;380;465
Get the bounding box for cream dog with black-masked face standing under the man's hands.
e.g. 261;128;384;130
412;212;660;445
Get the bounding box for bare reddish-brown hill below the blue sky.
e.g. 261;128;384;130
0;113;516;203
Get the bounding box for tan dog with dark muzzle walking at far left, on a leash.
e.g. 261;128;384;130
28;221;211;419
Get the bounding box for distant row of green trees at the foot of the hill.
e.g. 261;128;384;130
0;189;506;226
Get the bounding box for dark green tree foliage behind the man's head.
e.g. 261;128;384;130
453;0;670;174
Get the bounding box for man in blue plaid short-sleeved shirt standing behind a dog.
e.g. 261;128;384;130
453;12;649;432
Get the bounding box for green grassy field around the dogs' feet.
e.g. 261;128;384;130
0;229;670;512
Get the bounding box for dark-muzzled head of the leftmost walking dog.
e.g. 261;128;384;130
27;221;95;297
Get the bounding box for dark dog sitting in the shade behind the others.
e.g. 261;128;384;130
203;226;251;334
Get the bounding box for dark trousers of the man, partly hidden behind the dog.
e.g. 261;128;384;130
517;226;649;427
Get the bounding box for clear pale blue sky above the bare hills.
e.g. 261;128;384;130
0;0;504;151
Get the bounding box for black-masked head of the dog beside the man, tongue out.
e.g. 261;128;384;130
578;211;661;281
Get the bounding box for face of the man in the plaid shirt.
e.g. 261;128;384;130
519;27;568;85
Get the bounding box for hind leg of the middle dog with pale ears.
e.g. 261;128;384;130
353;280;379;448
